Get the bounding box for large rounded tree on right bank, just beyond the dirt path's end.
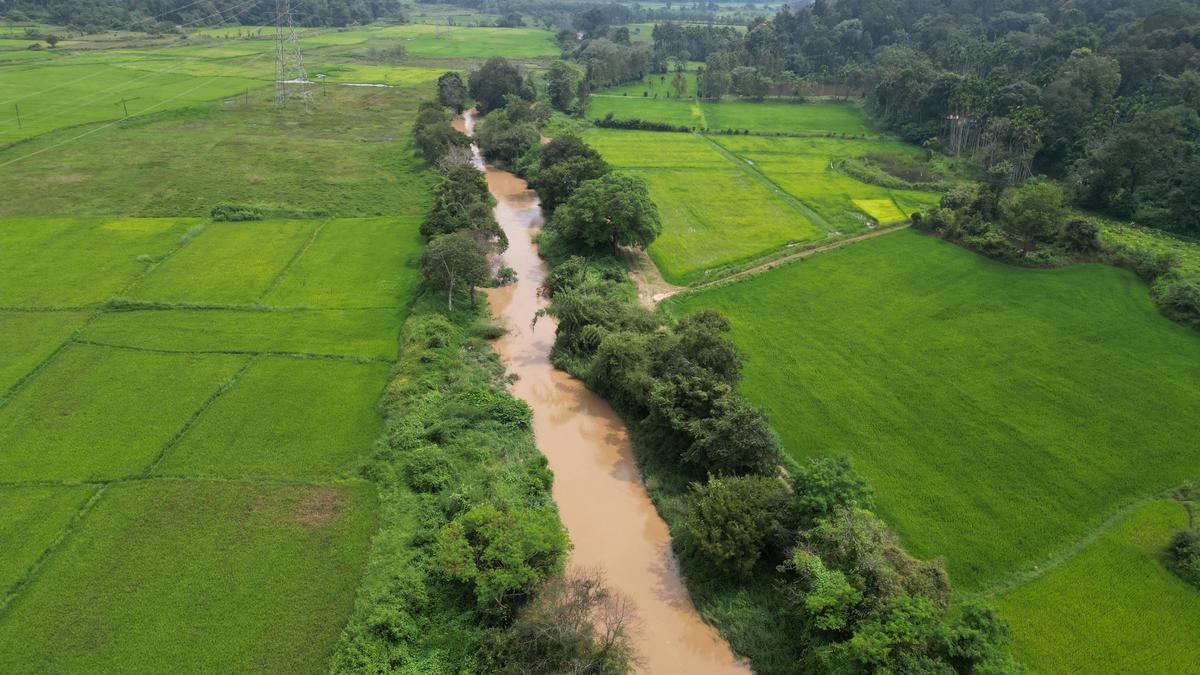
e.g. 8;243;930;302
551;173;662;253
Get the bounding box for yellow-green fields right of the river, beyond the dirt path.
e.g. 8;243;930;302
587;114;940;285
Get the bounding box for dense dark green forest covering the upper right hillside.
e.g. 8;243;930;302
655;0;1200;235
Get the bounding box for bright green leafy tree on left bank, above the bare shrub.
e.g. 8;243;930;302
431;502;568;616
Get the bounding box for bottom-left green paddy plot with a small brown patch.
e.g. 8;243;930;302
0;482;377;673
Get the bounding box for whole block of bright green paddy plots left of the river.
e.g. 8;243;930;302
0;211;421;673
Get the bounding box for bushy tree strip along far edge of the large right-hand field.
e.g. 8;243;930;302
912;181;1200;330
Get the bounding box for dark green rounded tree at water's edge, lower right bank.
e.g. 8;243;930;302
684;476;784;578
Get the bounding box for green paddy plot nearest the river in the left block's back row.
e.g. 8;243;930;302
263;216;424;307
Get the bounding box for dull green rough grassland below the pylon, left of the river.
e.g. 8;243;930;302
0;86;433;217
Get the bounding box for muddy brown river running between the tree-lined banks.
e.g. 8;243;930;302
455;112;749;674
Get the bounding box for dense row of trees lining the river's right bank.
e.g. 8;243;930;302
517;124;1019;673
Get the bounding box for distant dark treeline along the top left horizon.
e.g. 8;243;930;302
0;0;404;32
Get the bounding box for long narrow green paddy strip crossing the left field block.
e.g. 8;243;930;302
80;309;403;359
